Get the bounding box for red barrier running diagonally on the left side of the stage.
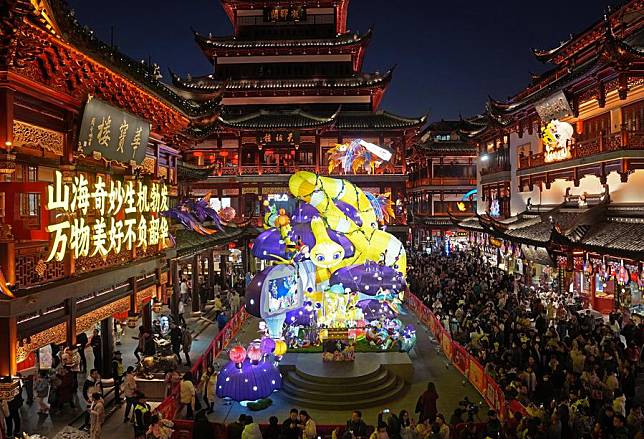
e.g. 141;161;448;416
156;308;249;419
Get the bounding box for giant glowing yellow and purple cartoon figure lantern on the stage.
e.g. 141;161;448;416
246;171;416;350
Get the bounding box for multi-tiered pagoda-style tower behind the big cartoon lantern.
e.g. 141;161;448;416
173;0;425;244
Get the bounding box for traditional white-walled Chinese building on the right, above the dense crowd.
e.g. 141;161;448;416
452;1;644;314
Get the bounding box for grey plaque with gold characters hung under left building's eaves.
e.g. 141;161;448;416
78;97;150;164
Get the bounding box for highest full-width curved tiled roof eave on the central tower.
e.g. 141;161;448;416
195;29;371;49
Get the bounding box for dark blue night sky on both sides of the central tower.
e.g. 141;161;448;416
69;0;614;120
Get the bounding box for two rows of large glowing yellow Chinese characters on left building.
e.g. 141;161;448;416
45;171;169;262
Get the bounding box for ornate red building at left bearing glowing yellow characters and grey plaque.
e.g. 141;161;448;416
0;0;228;378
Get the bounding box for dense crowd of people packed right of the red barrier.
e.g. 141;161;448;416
408;249;644;439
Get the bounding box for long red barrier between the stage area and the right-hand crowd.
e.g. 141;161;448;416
405;292;520;419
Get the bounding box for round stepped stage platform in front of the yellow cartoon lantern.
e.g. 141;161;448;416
280;353;413;411
